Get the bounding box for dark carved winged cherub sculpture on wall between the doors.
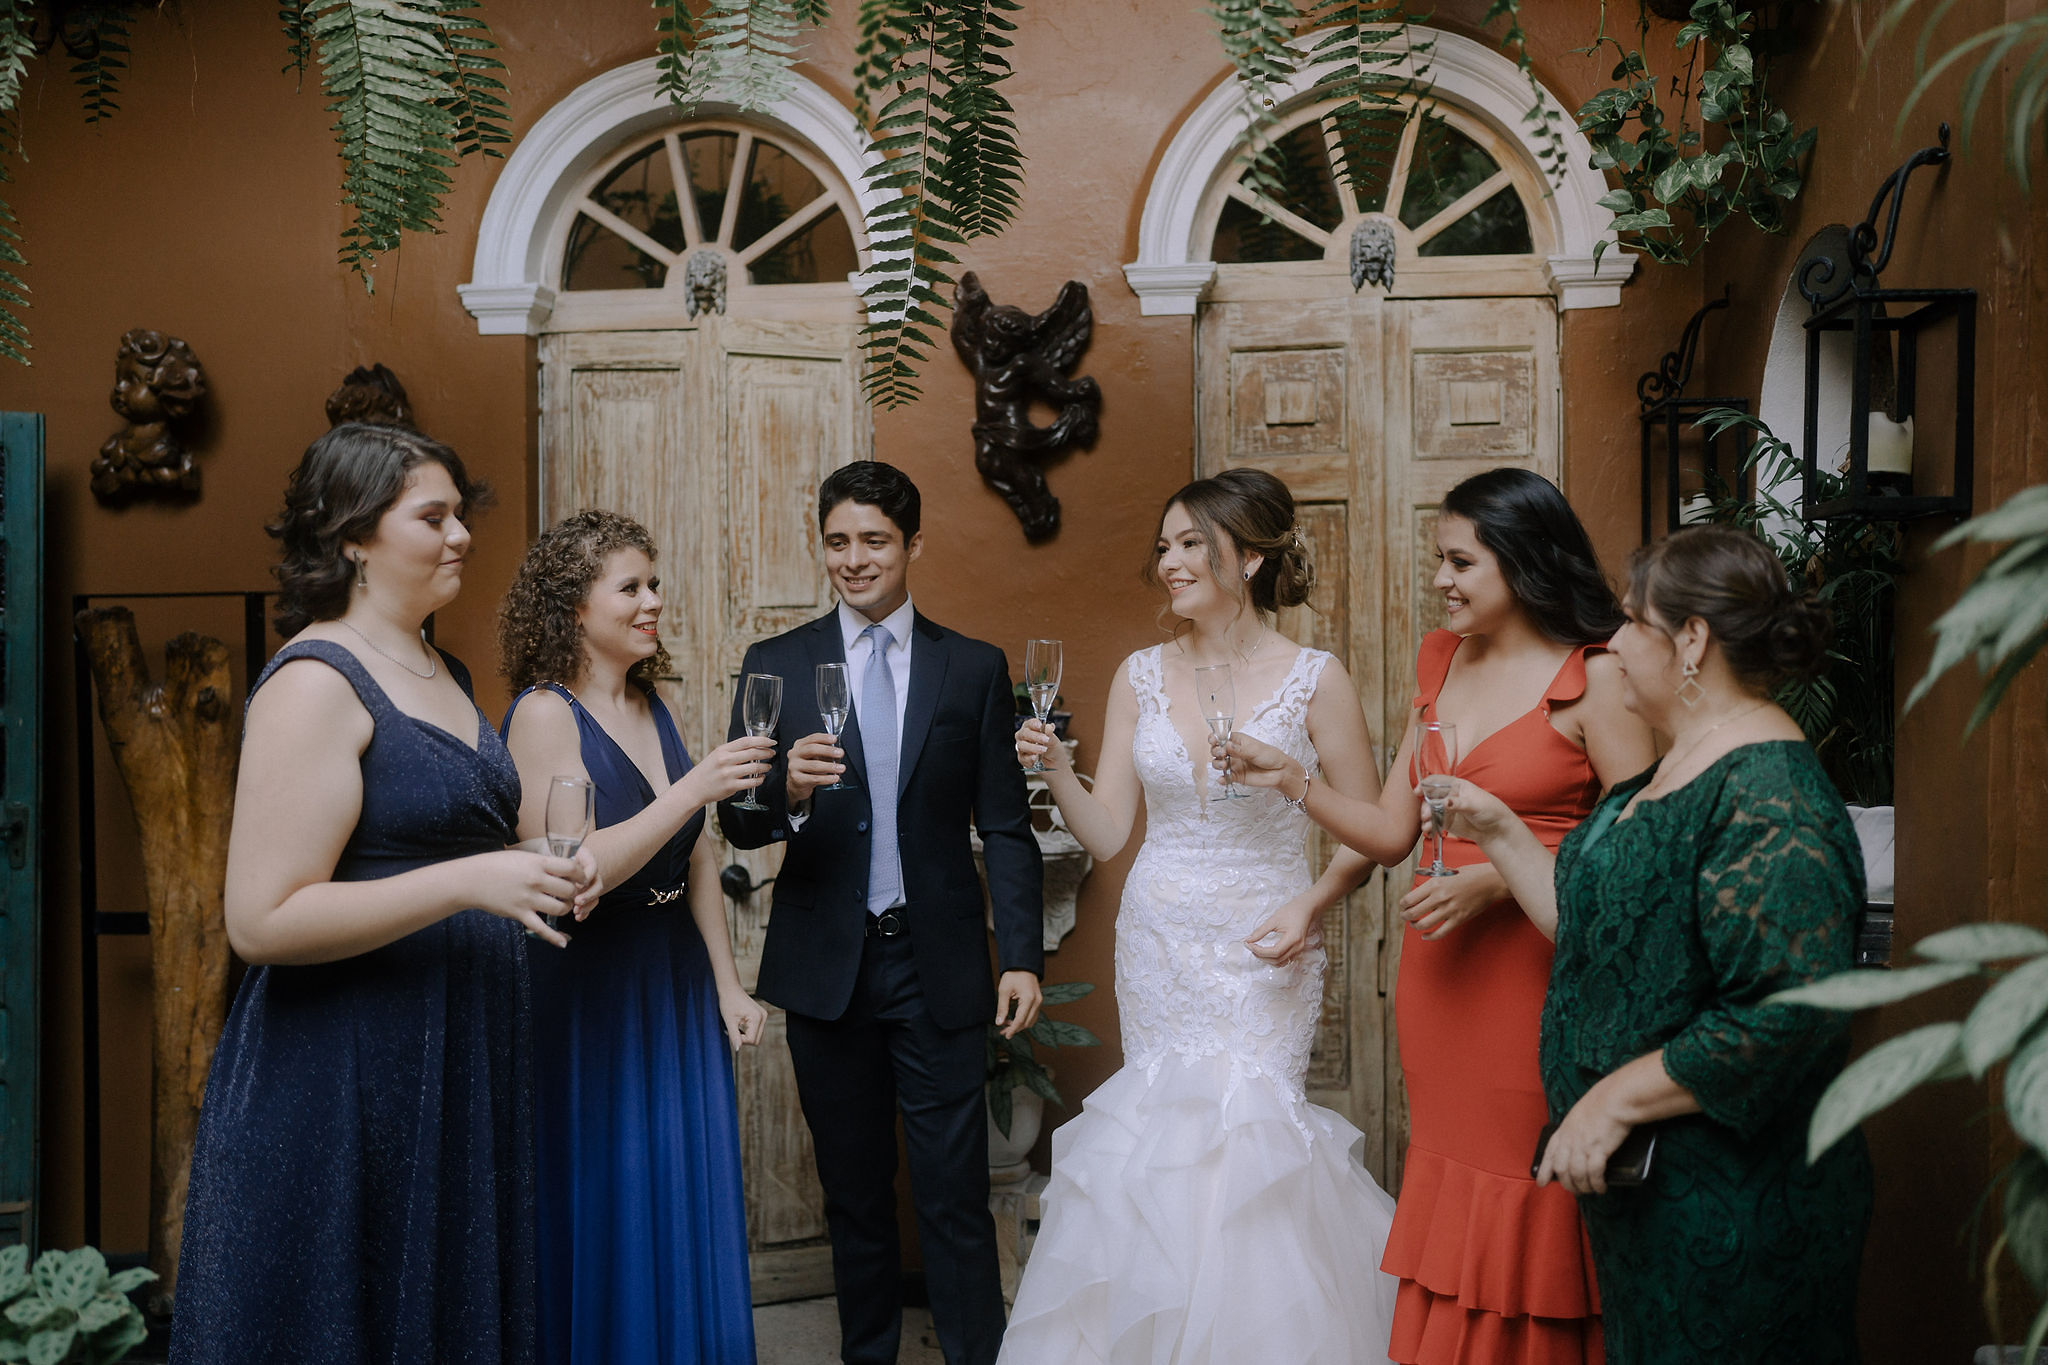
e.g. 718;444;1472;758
952;270;1102;540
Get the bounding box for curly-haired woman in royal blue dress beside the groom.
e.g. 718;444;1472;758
500;512;774;1365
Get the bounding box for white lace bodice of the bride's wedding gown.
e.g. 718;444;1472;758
1116;647;1329;1103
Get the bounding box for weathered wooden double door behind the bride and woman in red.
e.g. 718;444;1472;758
1196;286;1559;1189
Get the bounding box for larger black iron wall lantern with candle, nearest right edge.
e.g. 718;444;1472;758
1798;123;1976;522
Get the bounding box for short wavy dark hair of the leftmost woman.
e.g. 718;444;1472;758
264;422;492;639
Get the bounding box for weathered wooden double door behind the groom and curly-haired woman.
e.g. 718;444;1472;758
541;315;870;1302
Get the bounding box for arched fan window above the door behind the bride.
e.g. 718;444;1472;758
1208;100;1554;266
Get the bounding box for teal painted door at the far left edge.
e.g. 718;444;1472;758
0;413;43;1248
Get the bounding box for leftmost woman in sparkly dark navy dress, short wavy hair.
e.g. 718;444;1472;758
170;424;594;1365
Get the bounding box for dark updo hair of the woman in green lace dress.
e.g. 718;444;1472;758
1628;526;1835;692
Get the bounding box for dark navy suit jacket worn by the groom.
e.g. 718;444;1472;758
719;610;1044;1029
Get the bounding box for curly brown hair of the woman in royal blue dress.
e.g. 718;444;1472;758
498;508;672;692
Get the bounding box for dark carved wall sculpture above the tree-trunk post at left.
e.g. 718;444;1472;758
92;327;207;505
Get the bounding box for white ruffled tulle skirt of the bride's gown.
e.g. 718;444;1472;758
1001;1056;1395;1365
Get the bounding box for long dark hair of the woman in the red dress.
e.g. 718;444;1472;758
1442;469;1622;647
